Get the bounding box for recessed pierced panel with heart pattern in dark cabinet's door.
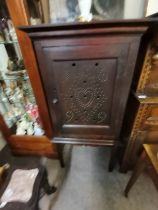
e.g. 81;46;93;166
53;59;116;125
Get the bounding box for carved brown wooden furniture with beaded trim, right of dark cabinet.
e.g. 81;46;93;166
121;30;158;172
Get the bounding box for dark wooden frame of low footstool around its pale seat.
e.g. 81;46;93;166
0;146;56;210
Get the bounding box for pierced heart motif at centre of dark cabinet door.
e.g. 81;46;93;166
75;88;94;108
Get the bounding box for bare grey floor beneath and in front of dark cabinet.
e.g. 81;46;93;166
40;146;158;210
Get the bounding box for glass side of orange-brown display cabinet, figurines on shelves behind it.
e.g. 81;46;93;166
0;0;44;135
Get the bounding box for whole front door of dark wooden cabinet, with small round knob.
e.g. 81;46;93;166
34;36;138;144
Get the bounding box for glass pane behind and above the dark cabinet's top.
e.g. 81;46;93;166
27;0;152;25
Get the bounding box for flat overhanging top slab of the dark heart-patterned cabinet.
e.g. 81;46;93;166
18;17;158;33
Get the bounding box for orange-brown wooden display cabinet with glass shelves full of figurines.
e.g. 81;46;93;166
0;0;59;161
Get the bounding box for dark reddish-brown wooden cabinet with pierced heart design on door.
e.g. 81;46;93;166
20;18;157;169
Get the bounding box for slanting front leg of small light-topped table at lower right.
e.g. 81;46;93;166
124;151;146;197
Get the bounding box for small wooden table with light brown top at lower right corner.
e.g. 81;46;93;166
125;144;158;197
